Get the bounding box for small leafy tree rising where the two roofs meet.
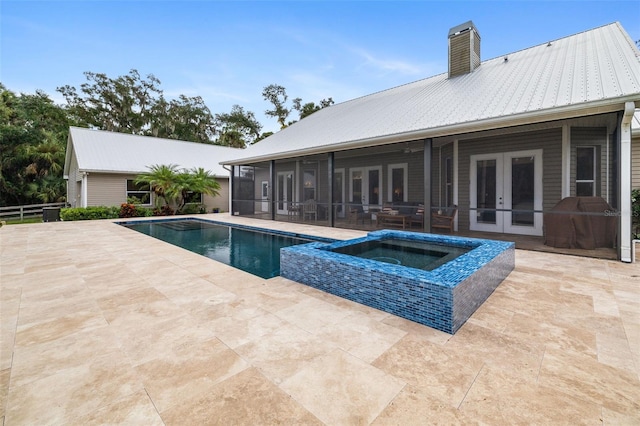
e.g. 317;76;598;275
215;105;262;148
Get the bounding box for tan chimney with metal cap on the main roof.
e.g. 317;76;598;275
449;21;480;78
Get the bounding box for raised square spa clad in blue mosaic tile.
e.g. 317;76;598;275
280;230;515;334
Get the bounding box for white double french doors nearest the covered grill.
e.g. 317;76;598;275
469;149;542;235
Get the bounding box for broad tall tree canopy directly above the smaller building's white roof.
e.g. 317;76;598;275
58;69;222;143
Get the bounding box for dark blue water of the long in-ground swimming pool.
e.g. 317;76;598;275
121;219;327;278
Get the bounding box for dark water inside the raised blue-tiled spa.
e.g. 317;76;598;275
332;239;470;271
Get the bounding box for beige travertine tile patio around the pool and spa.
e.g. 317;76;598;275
0;215;640;425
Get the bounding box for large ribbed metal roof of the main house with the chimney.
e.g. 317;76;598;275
227;22;640;164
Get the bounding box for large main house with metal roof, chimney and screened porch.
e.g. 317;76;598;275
223;21;640;261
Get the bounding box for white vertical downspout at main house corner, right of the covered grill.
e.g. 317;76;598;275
618;102;636;262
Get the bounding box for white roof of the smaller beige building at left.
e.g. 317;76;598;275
65;127;239;178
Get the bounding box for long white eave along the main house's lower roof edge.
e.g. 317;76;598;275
220;93;640;166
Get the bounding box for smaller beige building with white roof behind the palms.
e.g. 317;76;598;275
64;127;238;212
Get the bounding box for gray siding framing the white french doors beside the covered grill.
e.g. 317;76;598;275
458;128;562;231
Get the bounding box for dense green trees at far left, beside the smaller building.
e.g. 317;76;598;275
0;84;70;206
